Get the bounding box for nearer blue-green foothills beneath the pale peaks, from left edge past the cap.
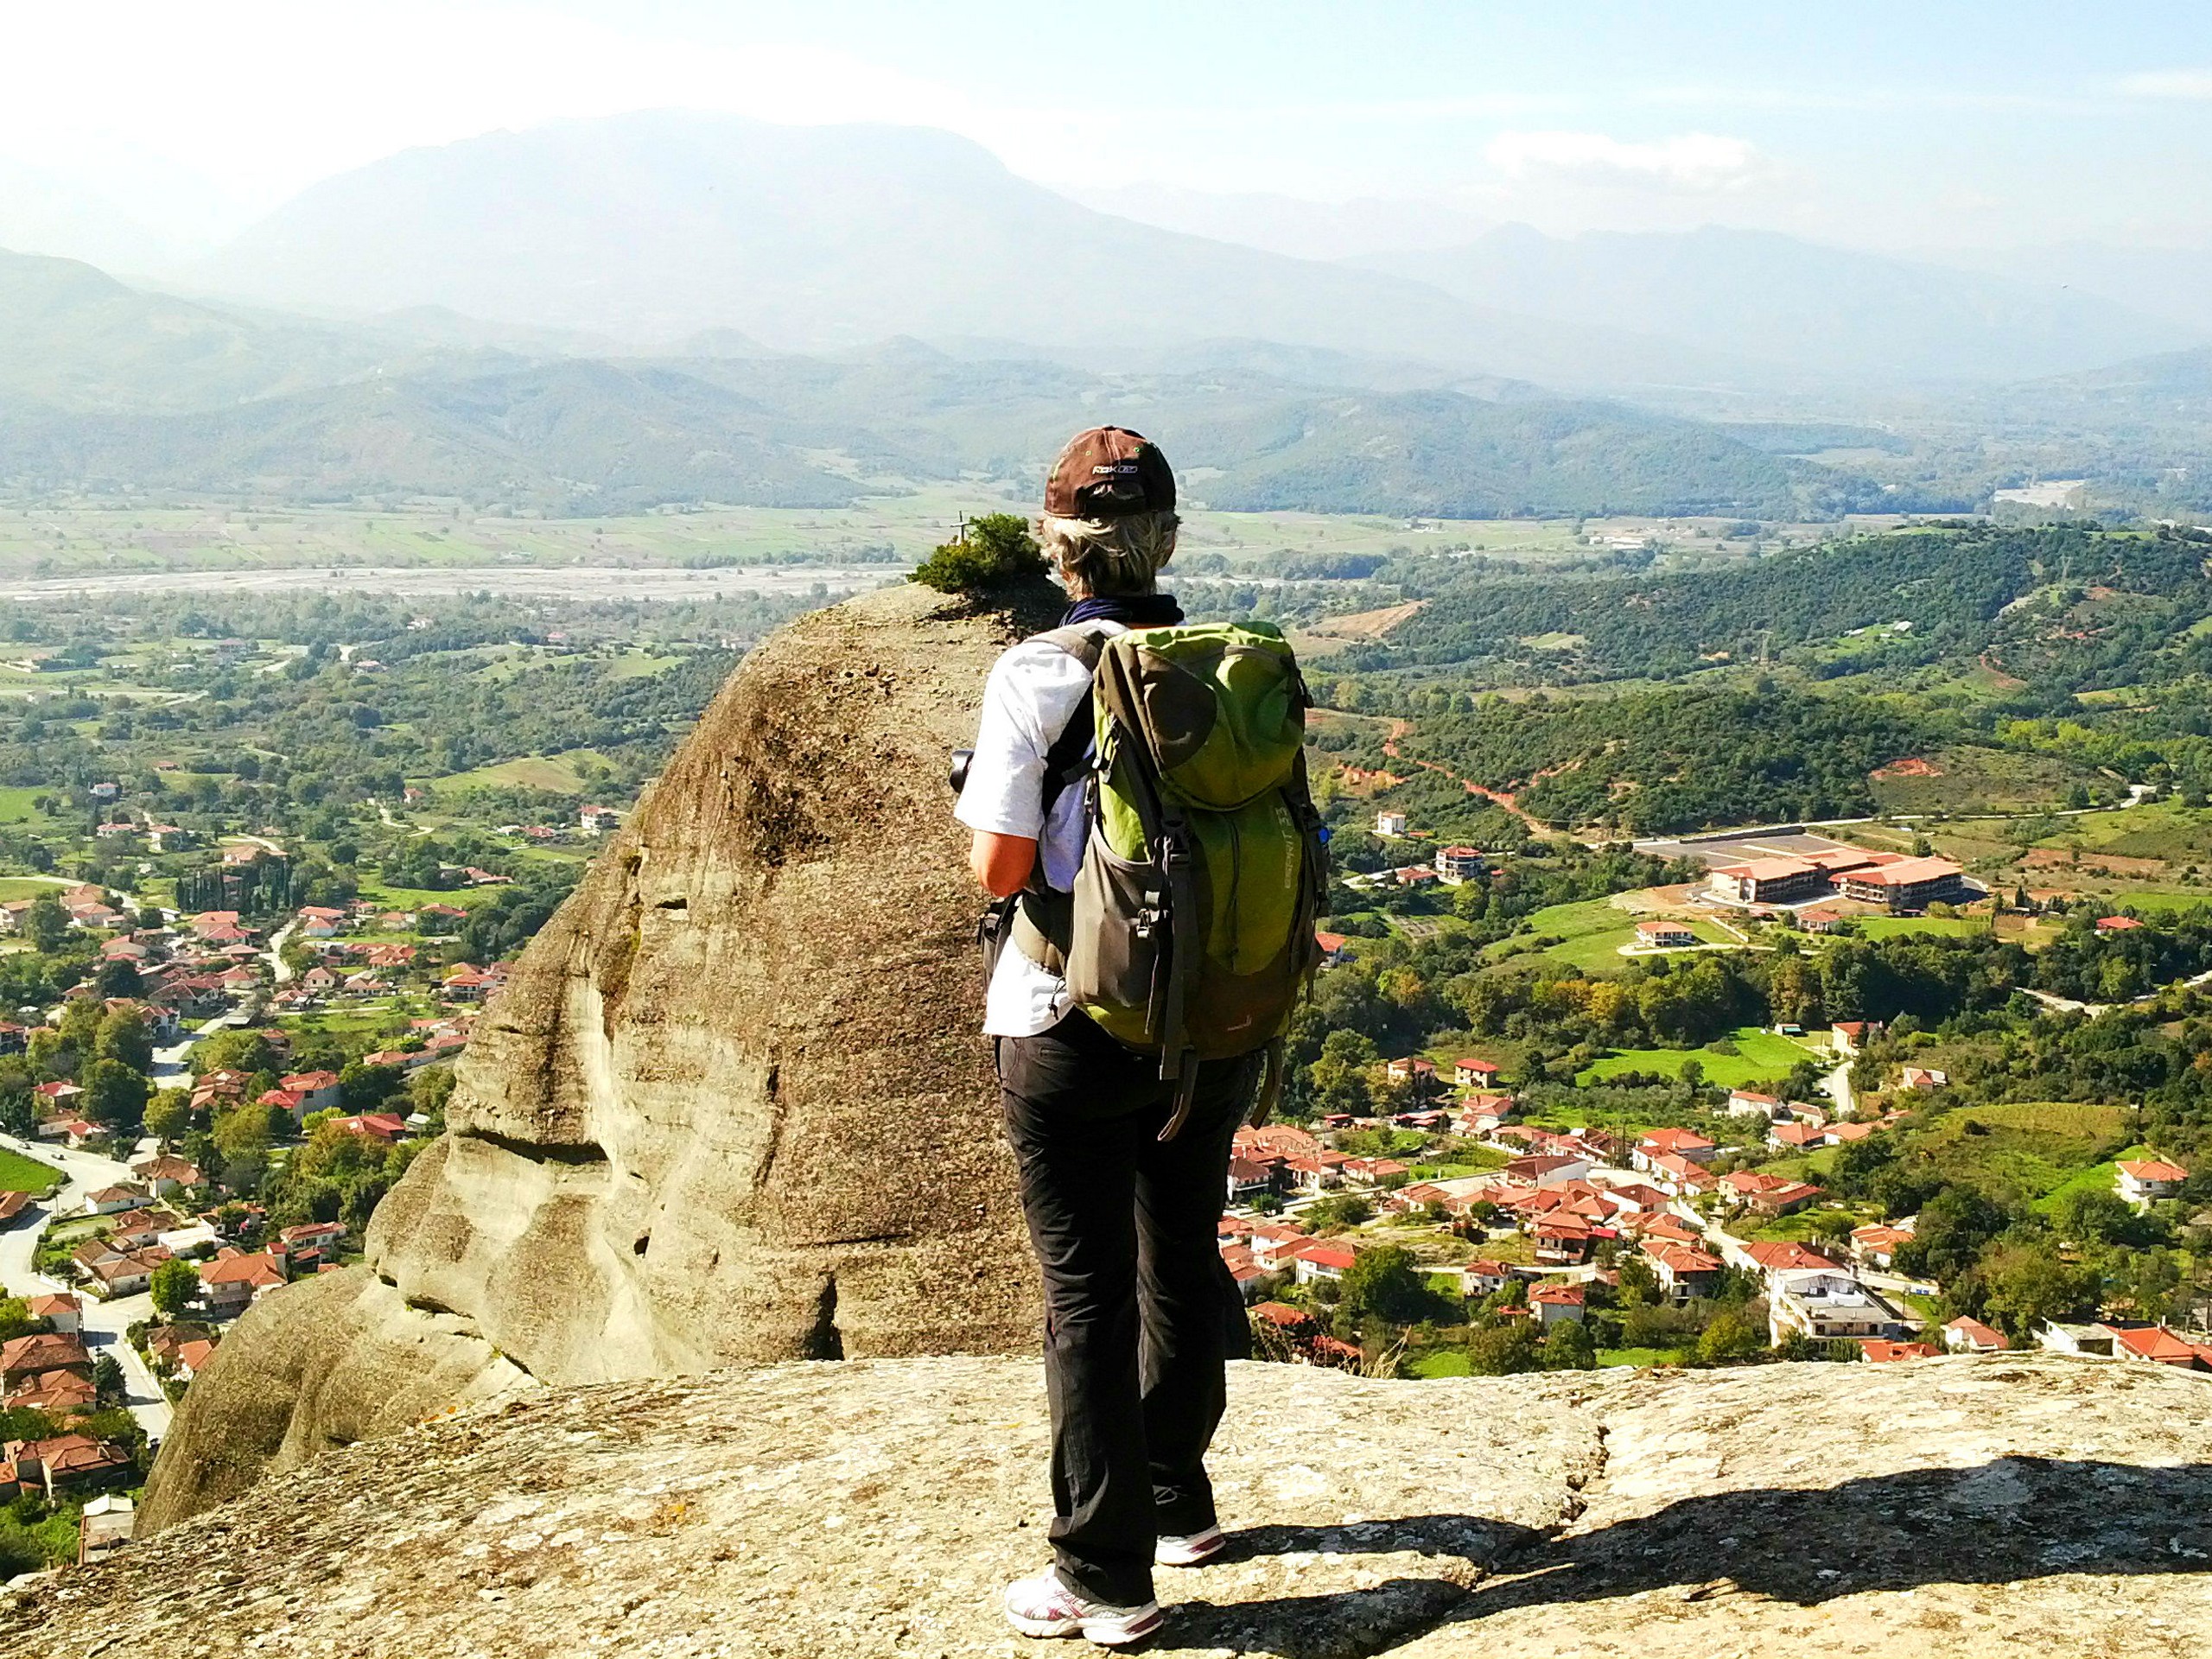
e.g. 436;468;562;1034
0;243;1880;518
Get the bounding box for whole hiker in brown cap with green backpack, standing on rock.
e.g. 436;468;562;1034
957;427;1325;1646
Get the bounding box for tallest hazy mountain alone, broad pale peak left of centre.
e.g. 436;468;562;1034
193;113;1760;387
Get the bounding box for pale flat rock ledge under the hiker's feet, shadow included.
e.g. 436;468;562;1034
17;1356;2212;1659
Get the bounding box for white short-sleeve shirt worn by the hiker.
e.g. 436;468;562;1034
953;620;1123;1038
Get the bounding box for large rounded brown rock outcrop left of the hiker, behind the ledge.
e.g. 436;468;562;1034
142;580;1055;1531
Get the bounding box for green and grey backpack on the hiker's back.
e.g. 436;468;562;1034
1013;624;1327;1139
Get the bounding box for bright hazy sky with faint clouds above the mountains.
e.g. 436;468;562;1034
0;0;2212;248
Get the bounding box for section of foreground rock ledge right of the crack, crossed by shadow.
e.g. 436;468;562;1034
1402;1356;2212;1659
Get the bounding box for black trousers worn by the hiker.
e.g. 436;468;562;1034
998;1013;1261;1606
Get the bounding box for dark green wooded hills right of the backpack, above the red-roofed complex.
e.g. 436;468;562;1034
1314;526;2212;834
